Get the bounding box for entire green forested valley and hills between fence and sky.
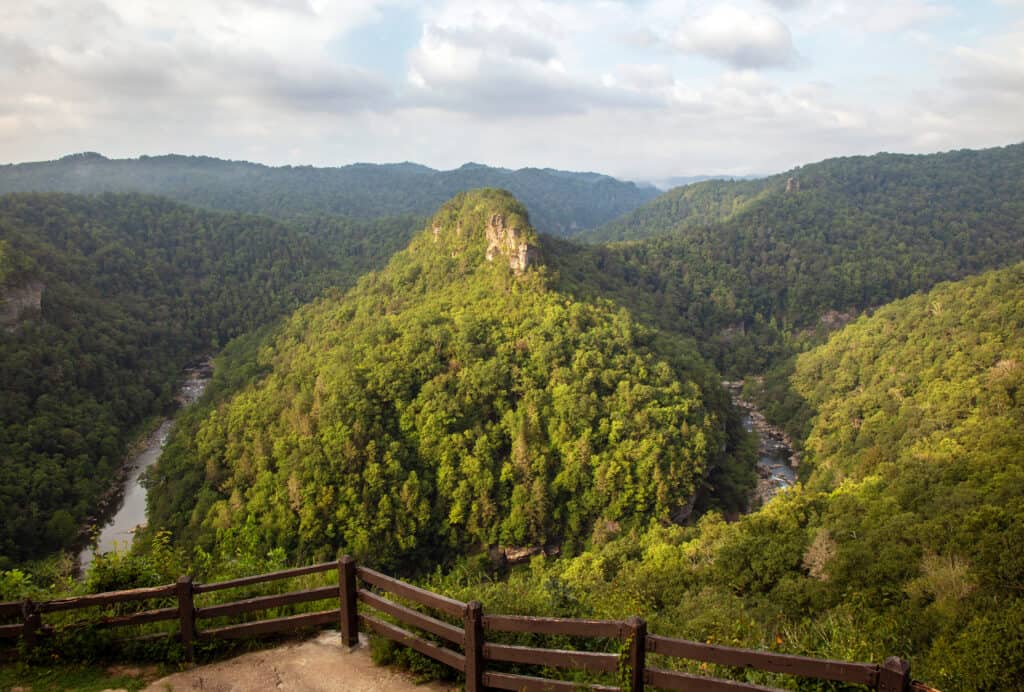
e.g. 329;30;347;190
0;144;1024;689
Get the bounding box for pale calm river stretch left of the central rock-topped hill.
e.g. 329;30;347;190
78;360;211;574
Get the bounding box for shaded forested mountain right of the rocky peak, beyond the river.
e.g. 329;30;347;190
563;144;1024;374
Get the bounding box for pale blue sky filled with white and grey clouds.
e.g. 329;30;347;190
0;0;1024;180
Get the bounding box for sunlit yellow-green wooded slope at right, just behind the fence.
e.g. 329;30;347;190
442;264;1024;690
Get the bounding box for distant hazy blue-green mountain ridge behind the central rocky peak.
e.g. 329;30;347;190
0;154;657;235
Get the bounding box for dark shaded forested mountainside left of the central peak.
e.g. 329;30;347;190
0;194;412;566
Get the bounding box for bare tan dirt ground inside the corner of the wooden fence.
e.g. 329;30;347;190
143;632;458;692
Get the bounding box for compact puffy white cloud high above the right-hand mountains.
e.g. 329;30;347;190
673;5;798;69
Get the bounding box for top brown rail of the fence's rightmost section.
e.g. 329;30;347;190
647;635;879;687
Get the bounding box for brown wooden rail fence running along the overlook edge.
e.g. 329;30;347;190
0;557;911;692
